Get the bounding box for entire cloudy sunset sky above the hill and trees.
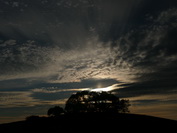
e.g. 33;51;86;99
0;0;177;123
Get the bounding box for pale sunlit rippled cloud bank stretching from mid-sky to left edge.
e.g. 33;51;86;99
0;37;135;82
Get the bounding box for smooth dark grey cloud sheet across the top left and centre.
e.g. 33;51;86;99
0;0;140;48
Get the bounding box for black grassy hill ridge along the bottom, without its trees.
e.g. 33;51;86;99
0;113;177;133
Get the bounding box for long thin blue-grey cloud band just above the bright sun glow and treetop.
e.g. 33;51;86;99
1;78;122;90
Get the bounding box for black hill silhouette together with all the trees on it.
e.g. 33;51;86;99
0;91;177;133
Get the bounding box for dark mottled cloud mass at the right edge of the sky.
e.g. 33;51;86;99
110;9;177;70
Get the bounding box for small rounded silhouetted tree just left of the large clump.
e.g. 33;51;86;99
47;106;65;117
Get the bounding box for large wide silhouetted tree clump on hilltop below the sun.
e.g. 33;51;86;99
65;91;130;113
